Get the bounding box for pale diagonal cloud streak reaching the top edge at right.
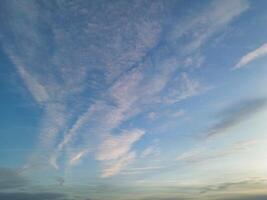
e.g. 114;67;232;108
170;0;249;54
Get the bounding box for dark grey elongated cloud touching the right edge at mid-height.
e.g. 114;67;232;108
204;98;267;138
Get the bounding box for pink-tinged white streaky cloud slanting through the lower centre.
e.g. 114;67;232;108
51;70;144;169
